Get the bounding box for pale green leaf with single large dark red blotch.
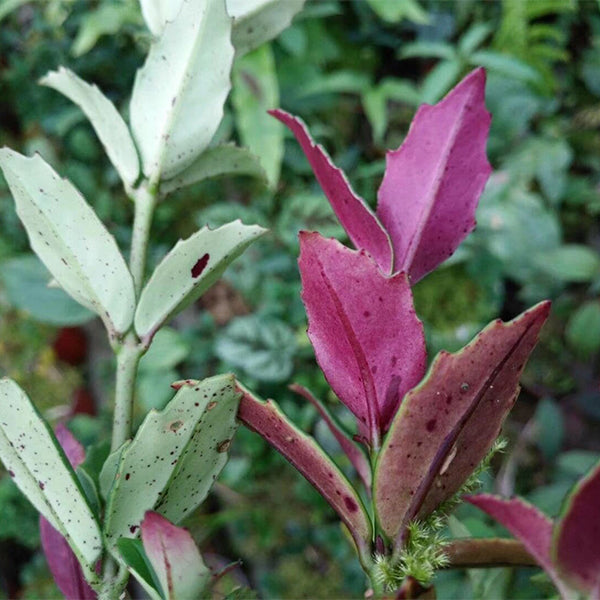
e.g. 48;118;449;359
135;221;266;338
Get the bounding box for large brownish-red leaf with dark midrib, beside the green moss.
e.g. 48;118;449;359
374;302;550;546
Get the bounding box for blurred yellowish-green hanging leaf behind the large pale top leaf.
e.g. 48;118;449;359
231;46;284;188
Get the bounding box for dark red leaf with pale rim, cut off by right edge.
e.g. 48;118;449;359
553;463;600;592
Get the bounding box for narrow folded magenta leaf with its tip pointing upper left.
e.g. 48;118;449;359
269;110;392;273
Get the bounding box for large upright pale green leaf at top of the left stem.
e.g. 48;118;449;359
130;0;233;184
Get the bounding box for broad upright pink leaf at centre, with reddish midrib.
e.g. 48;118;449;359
299;232;426;446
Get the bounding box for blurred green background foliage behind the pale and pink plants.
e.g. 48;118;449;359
0;0;600;599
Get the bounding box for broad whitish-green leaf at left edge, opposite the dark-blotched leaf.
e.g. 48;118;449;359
0;148;135;336
